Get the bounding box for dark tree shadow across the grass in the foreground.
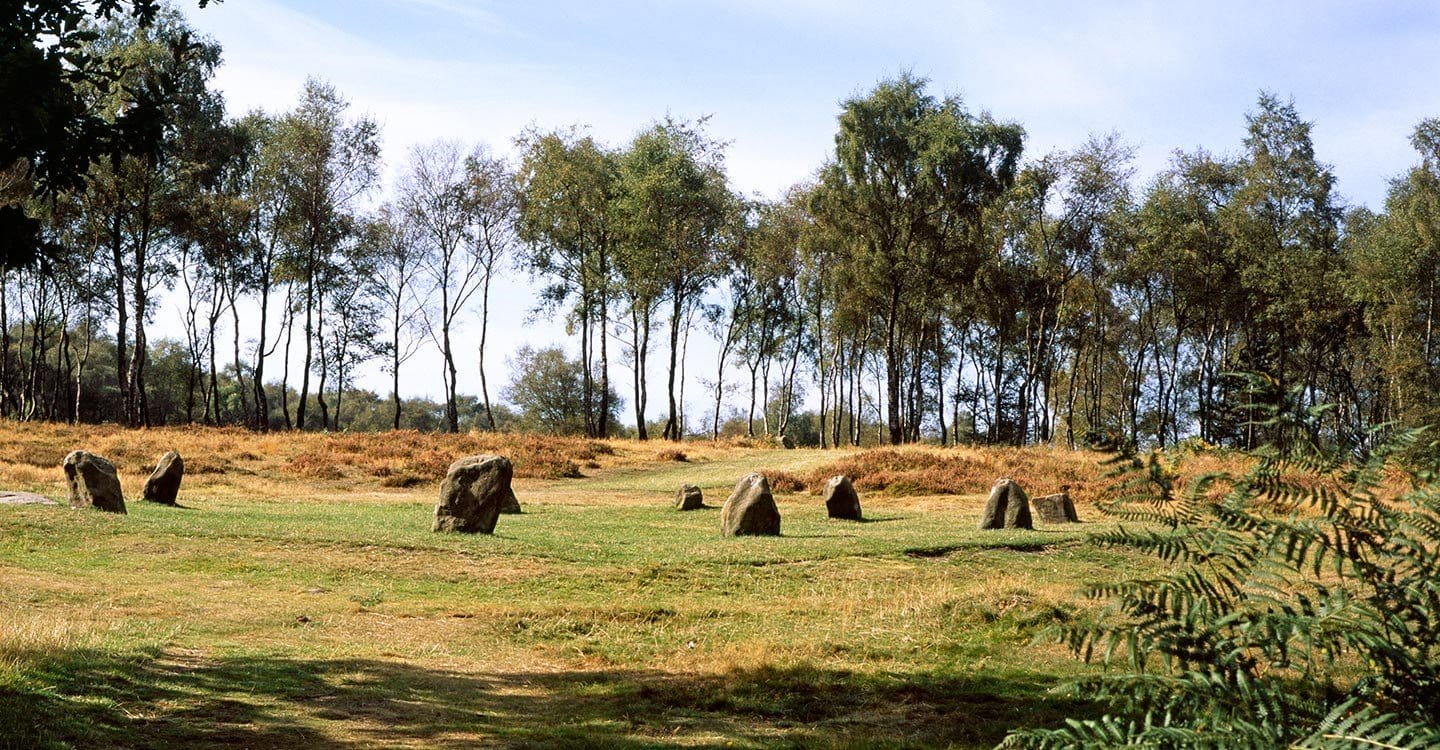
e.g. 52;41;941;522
0;649;1094;750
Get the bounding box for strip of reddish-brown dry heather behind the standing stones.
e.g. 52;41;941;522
0;422;1261;501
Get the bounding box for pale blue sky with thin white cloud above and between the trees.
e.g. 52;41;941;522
174;0;1440;422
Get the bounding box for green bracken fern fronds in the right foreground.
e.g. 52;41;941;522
1005;397;1440;747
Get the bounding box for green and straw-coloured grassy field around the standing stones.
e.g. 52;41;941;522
0;423;1146;749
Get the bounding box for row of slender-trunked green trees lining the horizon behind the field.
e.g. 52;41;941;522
0;0;1440;448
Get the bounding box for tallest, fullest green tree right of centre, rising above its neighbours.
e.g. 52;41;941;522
815;73;1024;443
